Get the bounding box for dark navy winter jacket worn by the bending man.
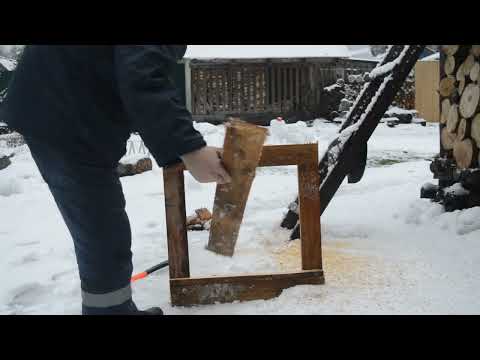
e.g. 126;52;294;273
4;45;206;166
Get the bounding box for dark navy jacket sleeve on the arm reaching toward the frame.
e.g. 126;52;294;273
114;45;206;166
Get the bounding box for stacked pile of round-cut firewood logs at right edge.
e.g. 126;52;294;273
422;45;480;210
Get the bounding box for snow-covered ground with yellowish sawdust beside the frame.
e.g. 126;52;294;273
0;120;480;314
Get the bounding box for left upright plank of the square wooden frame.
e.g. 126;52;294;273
163;164;190;279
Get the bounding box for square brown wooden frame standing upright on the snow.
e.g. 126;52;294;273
163;144;325;306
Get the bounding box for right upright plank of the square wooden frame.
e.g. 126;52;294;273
298;147;323;270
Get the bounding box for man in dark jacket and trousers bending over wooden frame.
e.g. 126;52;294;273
4;45;230;314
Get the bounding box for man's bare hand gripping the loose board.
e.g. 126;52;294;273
181;146;231;184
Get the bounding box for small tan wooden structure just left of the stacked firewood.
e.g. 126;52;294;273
415;53;440;122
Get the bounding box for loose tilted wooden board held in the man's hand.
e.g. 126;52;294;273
207;120;267;256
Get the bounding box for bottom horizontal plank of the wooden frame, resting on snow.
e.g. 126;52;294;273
170;269;325;306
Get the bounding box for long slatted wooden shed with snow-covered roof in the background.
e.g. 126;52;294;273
184;45;376;124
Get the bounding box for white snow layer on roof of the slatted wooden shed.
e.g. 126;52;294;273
185;45;350;59
